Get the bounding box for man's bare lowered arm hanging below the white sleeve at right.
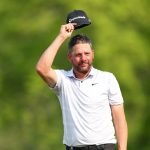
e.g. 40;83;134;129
111;104;128;150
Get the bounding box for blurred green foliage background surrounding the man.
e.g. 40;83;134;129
0;0;150;150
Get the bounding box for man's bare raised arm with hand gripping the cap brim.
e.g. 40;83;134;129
36;23;74;87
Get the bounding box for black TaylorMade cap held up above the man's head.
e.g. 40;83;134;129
66;10;91;29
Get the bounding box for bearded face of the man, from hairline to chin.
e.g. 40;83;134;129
68;43;94;74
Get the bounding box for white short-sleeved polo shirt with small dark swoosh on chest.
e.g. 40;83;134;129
53;68;123;146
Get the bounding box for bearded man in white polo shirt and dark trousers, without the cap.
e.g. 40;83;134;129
36;23;127;150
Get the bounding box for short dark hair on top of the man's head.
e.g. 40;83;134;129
68;34;92;52
